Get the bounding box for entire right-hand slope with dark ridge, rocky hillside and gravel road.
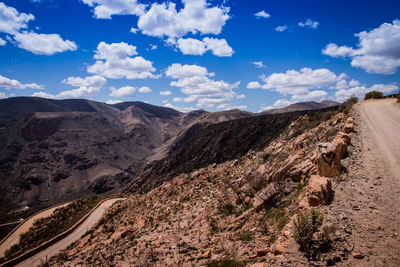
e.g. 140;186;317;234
1;99;400;267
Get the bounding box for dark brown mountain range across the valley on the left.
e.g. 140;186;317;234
0;97;251;223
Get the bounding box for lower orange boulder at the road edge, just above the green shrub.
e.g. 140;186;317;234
307;175;333;206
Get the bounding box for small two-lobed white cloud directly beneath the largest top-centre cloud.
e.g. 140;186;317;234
177;37;233;57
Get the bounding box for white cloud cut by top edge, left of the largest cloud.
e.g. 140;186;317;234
82;0;146;19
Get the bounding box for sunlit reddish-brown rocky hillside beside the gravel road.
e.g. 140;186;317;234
45;103;354;266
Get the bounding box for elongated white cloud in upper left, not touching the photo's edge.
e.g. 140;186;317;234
14;32;77;56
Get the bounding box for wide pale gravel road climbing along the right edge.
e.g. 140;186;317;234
327;99;400;266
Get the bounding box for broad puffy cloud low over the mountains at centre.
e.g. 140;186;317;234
165;63;240;108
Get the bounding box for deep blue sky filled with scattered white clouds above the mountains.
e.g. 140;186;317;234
0;0;400;112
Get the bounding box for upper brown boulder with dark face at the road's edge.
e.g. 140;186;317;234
317;143;342;177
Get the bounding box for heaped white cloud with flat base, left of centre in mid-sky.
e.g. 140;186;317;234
87;42;157;79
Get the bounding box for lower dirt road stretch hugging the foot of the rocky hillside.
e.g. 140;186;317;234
17;198;123;267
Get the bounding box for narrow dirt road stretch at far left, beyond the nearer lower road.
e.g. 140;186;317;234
0;202;70;257
